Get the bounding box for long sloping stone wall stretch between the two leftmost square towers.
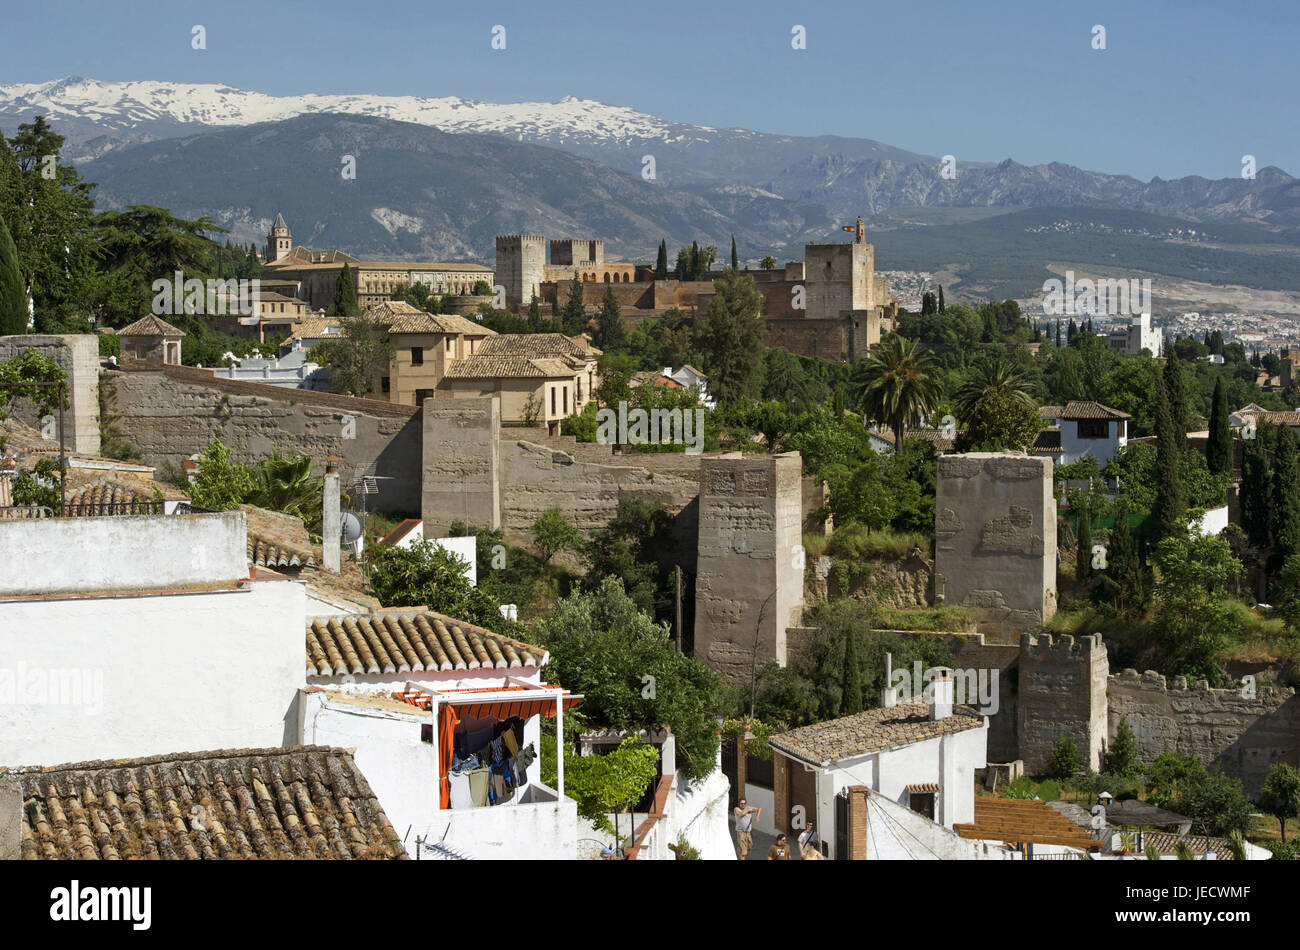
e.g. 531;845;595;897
105;366;421;515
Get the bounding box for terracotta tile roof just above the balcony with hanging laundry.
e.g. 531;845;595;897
307;608;546;676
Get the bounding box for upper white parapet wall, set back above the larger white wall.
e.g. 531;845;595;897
0;511;248;597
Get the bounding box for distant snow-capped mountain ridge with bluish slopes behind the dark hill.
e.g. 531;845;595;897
0;77;926;186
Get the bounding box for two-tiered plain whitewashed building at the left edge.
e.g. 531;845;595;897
0;511;306;767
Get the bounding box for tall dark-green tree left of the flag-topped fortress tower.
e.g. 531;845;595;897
697;270;764;407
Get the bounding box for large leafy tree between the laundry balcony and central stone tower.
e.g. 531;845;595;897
534;577;722;780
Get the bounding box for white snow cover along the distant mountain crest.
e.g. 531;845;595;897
0;77;716;143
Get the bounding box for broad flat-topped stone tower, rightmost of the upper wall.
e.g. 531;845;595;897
935;452;1057;637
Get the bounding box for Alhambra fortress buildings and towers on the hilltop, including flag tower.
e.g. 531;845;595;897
263;213;898;361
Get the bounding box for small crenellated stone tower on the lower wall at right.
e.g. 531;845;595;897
1017;634;1110;775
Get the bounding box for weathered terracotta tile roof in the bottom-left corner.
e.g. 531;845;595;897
13;746;406;860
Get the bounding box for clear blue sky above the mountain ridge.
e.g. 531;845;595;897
0;0;1300;181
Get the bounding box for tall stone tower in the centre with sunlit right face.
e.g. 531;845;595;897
696;452;803;682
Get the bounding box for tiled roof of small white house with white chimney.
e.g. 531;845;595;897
770;703;984;764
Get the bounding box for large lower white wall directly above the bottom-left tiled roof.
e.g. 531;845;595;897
0;577;306;765
